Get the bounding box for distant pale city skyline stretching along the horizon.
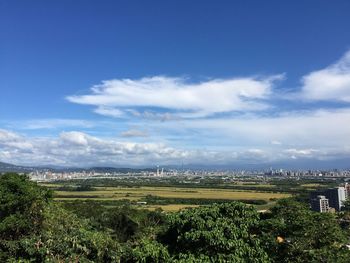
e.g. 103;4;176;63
29;166;350;181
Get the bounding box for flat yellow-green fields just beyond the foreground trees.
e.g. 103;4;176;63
46;184;291;211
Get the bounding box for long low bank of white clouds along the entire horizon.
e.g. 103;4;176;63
0;123;350;167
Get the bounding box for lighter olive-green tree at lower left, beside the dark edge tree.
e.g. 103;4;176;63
22;204;121;262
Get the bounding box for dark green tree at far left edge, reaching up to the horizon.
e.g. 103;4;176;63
0;173;51;259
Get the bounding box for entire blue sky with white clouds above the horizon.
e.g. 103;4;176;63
0;0;350;168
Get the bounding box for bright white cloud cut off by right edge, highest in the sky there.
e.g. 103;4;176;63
301;51;350;102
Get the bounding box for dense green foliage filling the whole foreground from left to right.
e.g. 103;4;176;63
0;174;350;262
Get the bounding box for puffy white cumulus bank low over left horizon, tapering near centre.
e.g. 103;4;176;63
0;130;189;166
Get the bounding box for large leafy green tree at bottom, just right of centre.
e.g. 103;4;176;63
160;202;269;262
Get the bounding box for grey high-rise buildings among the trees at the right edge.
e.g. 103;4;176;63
310;183;350;213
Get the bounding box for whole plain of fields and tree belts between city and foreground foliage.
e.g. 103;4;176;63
42;176;340;211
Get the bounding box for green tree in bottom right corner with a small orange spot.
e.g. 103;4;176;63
259;199;350;263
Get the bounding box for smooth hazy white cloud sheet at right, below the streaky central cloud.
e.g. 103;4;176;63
145;108;350;152
